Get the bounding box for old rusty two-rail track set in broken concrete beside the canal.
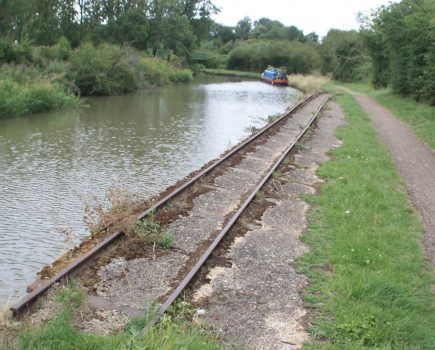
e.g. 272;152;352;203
11;94;328;326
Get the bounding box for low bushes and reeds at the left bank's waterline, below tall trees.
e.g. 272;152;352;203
0;38;193;118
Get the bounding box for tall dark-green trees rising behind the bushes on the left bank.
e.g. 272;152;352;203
0;0;217;55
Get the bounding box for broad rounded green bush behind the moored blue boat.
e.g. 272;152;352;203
227;40;321;74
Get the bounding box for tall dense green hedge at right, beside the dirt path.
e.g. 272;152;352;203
364;0;435;105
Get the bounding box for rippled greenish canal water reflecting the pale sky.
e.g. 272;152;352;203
0;77;301;306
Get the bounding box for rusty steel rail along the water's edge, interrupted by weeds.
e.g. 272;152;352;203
10;92;321;316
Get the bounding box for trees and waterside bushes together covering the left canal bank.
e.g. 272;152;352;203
0;0;208;118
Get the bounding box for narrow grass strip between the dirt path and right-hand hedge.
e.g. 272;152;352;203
346;83;435;150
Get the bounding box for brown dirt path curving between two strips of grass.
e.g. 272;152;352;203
343;88;435;266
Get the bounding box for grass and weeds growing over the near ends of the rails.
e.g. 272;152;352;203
8;283;219;350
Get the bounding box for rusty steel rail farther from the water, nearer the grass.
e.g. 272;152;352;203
143;94;327;333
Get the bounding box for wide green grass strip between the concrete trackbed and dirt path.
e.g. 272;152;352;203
299;89;435;350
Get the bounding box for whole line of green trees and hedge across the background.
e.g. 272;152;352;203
0;0;435;104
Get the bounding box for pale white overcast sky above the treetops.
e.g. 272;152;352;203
213;0;398;37
